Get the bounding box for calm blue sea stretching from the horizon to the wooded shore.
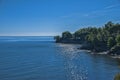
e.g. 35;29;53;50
0;37;120;80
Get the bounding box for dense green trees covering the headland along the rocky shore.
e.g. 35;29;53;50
54;21;120;55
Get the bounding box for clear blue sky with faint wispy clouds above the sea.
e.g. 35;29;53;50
0;0;120;36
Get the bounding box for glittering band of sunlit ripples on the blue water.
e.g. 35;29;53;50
59;44;88;80
